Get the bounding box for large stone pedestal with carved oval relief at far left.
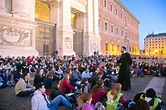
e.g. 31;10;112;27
0;15;39;57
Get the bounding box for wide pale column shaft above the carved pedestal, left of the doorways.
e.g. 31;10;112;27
12;0;35;20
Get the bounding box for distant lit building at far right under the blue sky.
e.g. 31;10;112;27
144;33;166;56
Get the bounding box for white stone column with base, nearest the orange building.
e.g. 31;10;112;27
83;0;101;55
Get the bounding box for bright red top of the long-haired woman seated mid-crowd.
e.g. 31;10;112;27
60;80;75;93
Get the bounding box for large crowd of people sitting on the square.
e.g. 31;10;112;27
0;48;166;110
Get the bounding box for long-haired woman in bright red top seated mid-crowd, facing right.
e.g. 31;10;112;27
60;74;77;93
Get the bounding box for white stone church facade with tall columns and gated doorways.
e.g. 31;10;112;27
0;0;139;56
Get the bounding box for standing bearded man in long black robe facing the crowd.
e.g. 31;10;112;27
117;46;132;91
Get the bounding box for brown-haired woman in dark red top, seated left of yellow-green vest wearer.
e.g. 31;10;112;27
92;79;108;105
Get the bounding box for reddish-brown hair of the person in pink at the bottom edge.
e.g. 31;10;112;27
77;93;92;107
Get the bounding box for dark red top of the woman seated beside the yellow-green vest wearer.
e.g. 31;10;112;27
91;88;108;105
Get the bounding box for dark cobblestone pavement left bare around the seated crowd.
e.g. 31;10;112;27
0;76;166;110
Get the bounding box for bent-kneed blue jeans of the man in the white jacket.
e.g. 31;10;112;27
49;95;72;110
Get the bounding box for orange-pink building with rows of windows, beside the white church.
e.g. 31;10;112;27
98;0;140;55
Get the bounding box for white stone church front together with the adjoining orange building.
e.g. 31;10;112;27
0;0;139;56
